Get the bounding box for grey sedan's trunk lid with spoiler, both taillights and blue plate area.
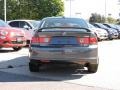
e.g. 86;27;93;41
32;28;97;47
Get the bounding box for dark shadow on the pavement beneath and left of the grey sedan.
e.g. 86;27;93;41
0;56;88;82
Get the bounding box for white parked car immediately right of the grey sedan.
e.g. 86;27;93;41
88;23;108;41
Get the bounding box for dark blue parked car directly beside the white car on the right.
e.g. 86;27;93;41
93;23;117;40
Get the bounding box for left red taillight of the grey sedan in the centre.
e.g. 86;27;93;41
32;36;50;44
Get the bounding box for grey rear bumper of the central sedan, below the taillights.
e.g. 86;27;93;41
29;45;98;64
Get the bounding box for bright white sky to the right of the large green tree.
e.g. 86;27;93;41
64;0;120;19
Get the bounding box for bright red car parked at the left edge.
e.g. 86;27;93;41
0;20;26;51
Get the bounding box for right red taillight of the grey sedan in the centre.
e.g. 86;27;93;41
78;37;97;45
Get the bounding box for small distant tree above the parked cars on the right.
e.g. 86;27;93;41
89;13;105;23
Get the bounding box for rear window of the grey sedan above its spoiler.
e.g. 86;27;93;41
41;18;88;28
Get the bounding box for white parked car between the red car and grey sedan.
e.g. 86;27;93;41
7;20;40;44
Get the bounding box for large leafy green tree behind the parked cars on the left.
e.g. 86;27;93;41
7;0;64;20
